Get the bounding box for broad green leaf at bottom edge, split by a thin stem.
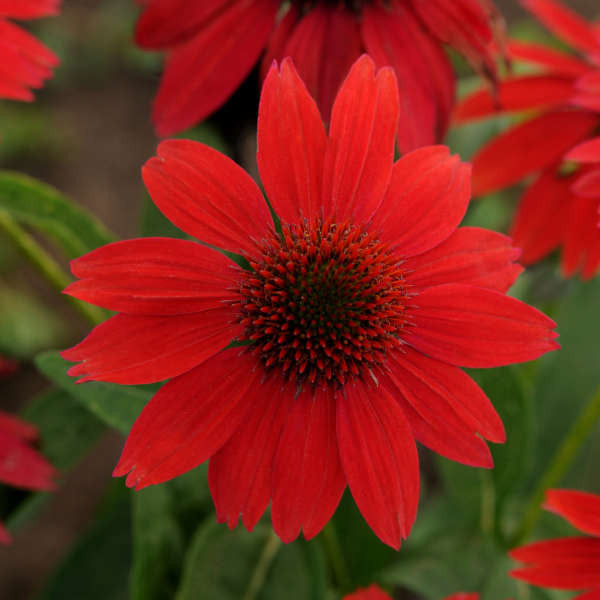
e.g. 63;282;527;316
176;516;327;600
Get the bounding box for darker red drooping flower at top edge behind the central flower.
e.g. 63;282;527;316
135;0;501;151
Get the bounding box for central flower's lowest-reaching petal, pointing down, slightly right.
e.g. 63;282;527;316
337;382;419;549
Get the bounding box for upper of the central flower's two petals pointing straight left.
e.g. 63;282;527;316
64;238;239;315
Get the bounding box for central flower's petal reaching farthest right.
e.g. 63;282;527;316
402;284;559;368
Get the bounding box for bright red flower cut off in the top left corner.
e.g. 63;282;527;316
0;0;61;102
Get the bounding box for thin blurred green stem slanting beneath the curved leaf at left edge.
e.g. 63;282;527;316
0;210;106;325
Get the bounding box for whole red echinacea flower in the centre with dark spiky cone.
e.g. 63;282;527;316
63;56;558;548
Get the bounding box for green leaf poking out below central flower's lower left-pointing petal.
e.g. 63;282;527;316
35;352;152;434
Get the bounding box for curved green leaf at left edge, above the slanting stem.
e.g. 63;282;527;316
0;171;115;258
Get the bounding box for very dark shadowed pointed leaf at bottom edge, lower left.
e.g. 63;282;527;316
39;482;132;600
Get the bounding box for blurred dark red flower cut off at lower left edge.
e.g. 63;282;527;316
0;411;56;544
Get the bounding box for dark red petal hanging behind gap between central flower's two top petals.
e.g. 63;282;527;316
277;4;362;121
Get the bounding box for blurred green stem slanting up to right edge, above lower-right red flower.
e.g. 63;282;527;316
510;388;600;547
